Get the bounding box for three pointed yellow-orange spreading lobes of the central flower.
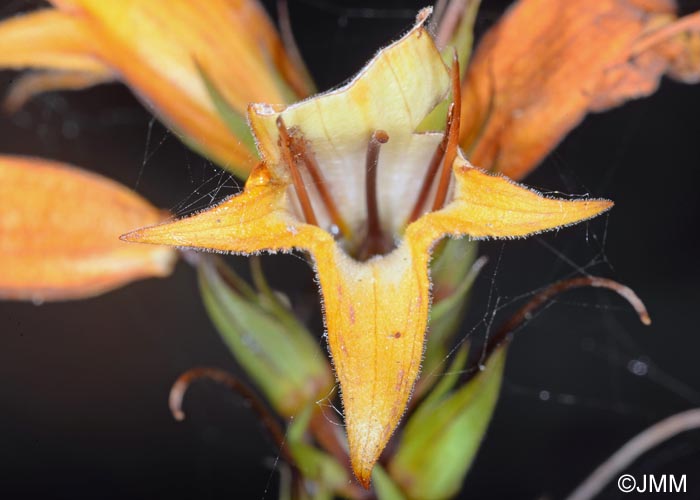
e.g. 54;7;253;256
124;158;612;487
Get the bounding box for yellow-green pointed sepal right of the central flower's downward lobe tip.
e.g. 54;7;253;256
389;345;506;500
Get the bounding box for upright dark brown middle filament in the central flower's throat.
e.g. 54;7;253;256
360;130;391;259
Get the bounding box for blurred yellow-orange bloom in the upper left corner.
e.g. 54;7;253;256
0;0;309;177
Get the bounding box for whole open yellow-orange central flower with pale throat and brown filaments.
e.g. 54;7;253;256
124;16;612;486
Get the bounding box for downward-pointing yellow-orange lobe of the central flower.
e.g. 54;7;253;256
314;244;430;488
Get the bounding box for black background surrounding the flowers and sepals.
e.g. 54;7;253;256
0;0;700;499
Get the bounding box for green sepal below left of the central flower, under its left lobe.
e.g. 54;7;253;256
198;256;334;416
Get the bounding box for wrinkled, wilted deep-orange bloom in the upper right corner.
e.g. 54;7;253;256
461;0;700;179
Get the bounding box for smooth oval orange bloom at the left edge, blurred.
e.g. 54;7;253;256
0;156;176;301
